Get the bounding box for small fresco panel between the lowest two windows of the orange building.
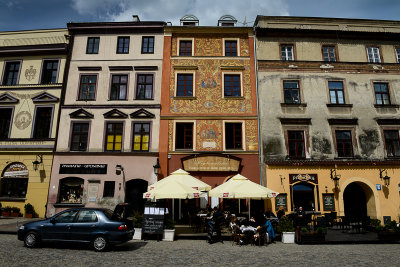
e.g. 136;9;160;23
196;120;222;151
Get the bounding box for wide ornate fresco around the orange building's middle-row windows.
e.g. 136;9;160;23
170;59;254;114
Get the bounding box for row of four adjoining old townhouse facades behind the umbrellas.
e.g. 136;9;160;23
0;15;400;224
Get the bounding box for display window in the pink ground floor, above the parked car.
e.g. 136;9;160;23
58;177;84;204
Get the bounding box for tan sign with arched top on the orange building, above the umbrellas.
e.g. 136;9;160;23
182;155;241;172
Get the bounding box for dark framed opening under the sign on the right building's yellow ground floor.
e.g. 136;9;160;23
293;182;315;210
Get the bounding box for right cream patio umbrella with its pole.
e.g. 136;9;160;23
209;174;279;219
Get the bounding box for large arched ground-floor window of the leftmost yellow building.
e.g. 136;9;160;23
1;162;29;198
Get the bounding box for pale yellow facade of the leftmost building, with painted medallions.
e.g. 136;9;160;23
0;29;68;217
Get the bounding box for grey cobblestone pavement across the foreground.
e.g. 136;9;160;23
0;235;400;267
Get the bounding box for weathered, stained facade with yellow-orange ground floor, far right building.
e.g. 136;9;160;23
255;16;400;223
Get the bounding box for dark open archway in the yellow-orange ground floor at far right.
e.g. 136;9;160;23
343;182;372;219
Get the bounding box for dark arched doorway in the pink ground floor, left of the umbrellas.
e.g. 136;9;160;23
125;179;149;212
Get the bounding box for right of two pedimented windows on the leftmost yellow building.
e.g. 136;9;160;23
33;107;53;139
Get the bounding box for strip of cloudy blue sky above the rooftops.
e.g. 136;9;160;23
0;0;400;31
